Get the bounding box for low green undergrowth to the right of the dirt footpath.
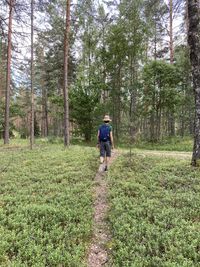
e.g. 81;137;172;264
107;155;200;267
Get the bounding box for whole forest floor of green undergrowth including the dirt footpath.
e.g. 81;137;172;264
0;142;200;267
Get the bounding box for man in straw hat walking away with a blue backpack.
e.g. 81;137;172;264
97;115;114;171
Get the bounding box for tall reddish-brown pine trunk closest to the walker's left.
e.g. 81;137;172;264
63;0;70;146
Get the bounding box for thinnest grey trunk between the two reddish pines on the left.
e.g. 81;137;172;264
30;0;34;149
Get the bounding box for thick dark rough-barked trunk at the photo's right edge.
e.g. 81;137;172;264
187;0;200;166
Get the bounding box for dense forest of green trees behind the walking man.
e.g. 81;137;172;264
0;0;194;142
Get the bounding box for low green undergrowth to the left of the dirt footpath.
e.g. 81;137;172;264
0;145;97;267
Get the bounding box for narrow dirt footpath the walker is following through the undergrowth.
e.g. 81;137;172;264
88;150;119;267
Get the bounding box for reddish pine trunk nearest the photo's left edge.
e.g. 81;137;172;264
4;0;14;144
